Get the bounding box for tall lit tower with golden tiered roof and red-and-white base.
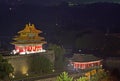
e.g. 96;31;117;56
12;23;46;54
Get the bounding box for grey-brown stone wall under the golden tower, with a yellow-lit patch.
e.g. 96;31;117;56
4;51;55;74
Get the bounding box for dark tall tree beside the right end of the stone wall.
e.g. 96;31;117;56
48;44;65;69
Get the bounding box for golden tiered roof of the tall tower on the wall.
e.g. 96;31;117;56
12;23;46;44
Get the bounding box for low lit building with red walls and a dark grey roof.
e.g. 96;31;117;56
70;54;102;70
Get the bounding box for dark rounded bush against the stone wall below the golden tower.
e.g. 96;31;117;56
30;55;54;74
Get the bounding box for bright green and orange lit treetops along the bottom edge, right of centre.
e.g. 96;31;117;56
56;69;118;81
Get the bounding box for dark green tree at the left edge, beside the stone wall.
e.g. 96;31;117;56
0;55;14;79
